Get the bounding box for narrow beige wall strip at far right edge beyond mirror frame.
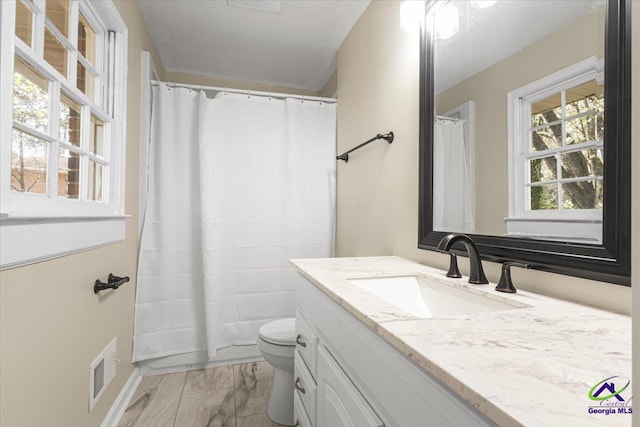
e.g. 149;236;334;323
631;1;640;427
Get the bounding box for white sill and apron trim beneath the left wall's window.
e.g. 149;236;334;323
0;217;126;270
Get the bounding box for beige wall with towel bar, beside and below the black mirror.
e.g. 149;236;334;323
336;1;640;313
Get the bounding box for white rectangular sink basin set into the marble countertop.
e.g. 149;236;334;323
348;276;526;319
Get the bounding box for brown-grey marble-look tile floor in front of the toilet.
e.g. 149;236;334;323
118;362;288;427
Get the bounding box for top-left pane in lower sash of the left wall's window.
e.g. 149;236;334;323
13;56;49;132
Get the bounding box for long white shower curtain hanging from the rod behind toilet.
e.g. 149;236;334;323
134;85;336;361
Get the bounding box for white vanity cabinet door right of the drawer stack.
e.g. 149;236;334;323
317;345;384;427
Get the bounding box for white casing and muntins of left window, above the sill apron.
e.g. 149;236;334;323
5;1;127;216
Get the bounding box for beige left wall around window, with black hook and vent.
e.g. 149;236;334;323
0;1;164;427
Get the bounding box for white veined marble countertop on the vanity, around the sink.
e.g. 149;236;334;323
291;256;632;427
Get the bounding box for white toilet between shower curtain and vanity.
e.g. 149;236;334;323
258;317;296;426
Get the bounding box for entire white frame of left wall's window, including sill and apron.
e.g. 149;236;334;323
0;0;128;269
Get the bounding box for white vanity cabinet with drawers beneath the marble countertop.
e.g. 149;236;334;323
294;274;495;427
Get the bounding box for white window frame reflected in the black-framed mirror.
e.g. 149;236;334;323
505;56;606;243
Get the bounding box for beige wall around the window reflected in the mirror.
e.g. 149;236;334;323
436;10;605;235
